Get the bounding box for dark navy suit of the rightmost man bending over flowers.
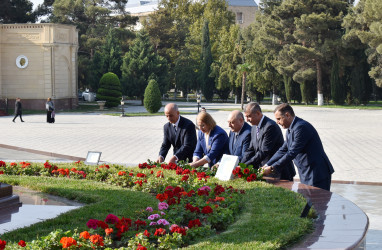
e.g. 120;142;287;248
267;117;334;186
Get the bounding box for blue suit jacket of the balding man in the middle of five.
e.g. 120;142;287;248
228;122;251;162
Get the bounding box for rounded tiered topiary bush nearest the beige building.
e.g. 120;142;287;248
97;72;122;108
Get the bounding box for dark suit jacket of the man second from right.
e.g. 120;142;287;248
242;116;296;180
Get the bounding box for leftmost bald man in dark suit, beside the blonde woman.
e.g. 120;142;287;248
157;103;196;163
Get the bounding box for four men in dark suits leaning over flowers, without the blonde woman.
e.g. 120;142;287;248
157;102;334;190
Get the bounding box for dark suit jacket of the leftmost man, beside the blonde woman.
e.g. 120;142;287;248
159;116;196;162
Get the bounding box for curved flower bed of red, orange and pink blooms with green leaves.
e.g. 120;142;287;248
0;161;309;250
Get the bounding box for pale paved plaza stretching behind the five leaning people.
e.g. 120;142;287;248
0;102;382;249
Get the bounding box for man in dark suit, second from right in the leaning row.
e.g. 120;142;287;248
241;102;296;181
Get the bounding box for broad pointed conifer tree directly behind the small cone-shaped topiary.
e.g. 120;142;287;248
122;30;168;104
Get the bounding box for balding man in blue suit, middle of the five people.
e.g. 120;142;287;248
227;110;251;162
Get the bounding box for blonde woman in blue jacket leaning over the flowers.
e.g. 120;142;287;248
190;112;229;167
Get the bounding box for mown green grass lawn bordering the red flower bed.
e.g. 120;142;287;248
0;165;313;249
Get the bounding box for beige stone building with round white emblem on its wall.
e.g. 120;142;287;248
0;23;78;110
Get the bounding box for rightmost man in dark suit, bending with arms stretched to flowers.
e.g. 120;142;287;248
263;103;334;191
